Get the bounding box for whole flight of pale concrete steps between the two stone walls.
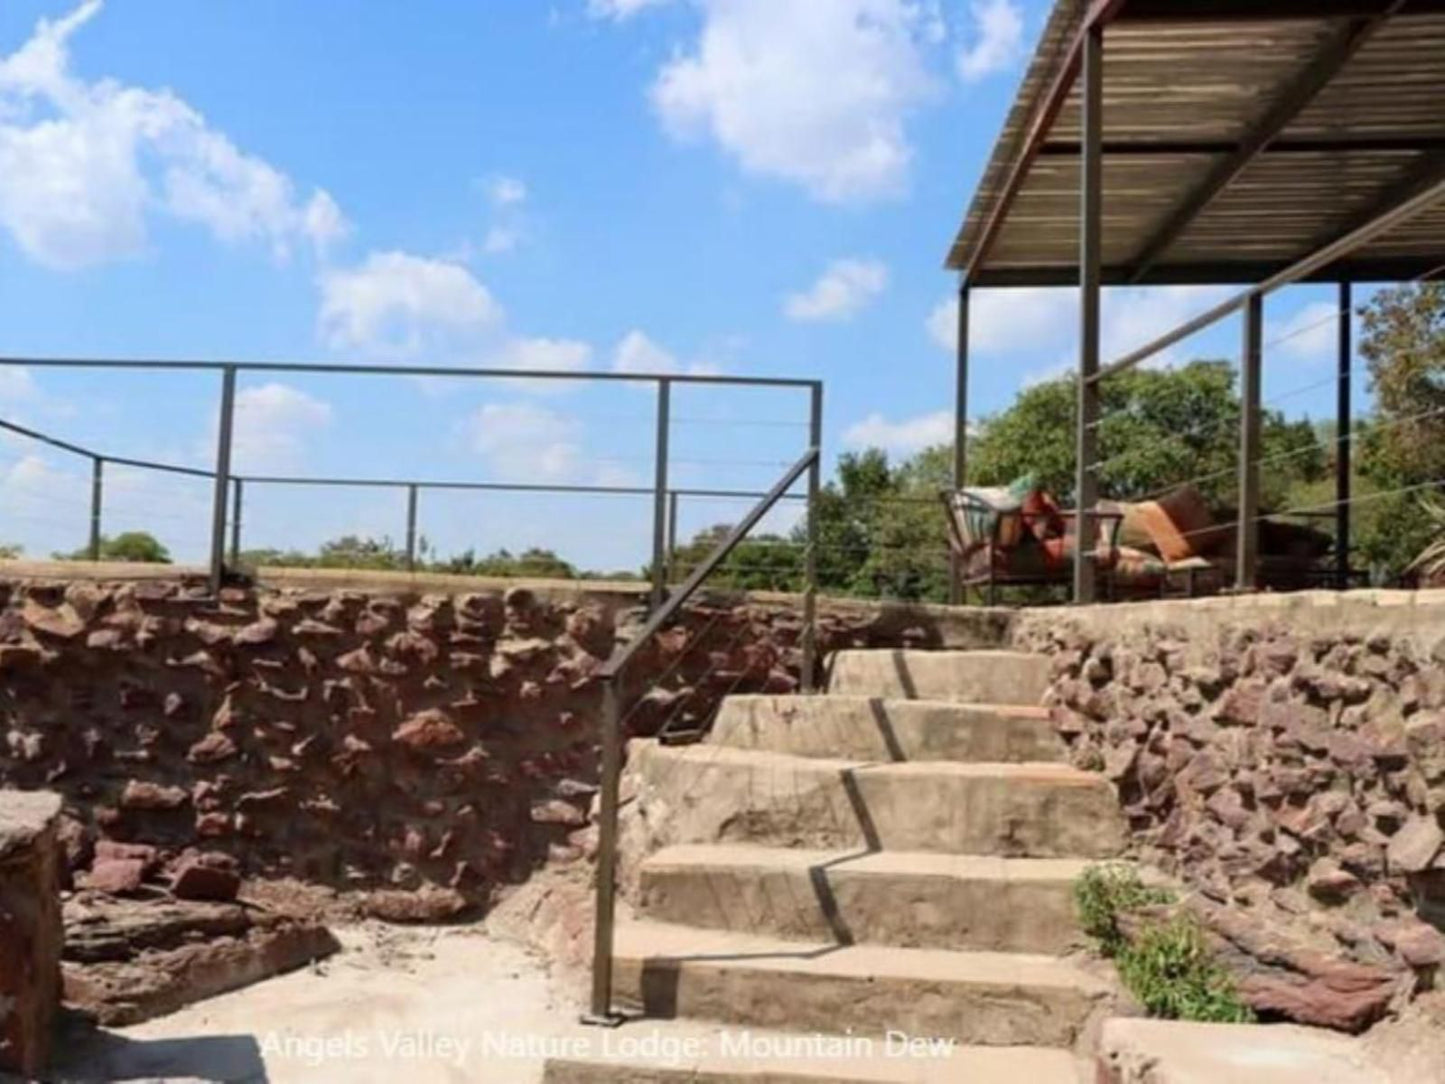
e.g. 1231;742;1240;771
546;652;1124;1084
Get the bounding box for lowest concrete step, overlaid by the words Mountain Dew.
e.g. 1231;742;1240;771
543;1020;1092;1084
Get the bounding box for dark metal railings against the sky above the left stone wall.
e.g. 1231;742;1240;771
0;357;822;608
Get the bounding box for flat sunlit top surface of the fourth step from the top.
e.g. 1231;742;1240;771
643;843;1097;882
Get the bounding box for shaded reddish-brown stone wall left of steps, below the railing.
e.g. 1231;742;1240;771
0;572;1007;918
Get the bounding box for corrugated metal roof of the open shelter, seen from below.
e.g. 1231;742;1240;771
948;0;1445;285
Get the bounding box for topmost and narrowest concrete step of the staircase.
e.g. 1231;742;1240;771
828;650;1049;705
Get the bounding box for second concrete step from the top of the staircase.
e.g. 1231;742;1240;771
708;697;1068;763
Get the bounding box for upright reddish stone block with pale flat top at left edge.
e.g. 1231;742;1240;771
0;791;62;1078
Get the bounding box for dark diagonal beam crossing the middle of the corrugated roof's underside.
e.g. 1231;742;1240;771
1130;0;1405;282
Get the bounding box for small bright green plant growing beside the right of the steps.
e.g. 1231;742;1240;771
1114;915;1254;1023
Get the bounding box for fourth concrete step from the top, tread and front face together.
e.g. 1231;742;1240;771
642;844;1090;954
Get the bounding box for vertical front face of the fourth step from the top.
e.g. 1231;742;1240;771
642;866;1079;954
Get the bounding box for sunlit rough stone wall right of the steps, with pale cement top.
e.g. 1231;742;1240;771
1016;593;1445;1029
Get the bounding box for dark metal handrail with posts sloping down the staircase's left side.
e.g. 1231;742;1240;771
582;444;822;1026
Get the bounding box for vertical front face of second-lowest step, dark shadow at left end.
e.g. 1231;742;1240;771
614;958;1094;1046
